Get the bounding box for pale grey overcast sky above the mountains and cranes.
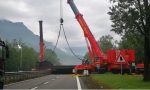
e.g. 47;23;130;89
0;0;119;49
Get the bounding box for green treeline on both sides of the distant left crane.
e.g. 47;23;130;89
5;40;60;72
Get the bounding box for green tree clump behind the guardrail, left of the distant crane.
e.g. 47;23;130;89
6;42;38;71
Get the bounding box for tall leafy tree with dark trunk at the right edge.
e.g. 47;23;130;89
108;0;150;81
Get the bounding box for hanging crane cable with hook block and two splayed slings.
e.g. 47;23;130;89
53;0;84;60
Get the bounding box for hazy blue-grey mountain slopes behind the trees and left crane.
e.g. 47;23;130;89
0;20;81;65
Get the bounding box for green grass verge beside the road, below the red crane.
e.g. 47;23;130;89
90;73;150;89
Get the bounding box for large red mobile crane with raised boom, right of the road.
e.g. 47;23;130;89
68;0;135;72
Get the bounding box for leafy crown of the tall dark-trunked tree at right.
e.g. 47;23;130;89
108;0;146;34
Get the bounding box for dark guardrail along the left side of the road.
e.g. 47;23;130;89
3;70;51;84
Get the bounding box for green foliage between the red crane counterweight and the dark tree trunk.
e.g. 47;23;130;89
119;33;144;63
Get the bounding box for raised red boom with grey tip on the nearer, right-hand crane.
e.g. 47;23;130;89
68;0;104;62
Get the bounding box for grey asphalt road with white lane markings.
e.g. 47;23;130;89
4;75;86;90
